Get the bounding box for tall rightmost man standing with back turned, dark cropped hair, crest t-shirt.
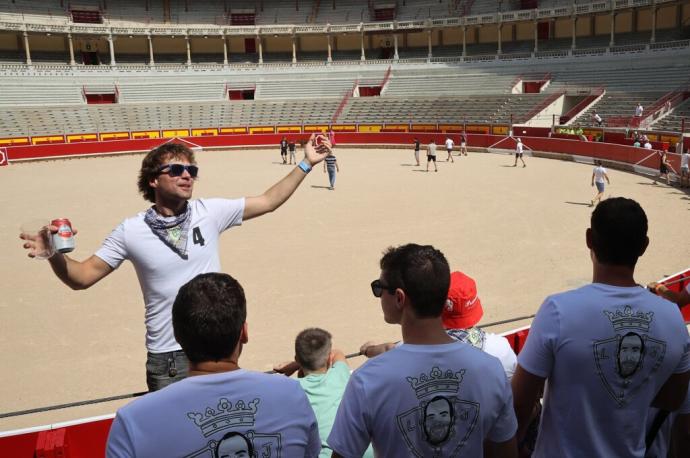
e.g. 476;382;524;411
512;197;690;458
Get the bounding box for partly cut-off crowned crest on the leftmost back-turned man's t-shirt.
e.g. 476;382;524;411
180;398;283;458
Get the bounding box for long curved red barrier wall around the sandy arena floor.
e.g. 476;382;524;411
2;132;680;171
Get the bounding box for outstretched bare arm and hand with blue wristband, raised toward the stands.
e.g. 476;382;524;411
242;134;331;221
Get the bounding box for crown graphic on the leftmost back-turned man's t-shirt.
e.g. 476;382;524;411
187;398;260;437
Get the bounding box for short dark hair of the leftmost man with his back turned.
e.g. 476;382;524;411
172;273;247;363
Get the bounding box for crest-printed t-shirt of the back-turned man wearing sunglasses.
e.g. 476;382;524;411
328;342;517;458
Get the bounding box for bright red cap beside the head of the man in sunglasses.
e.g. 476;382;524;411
441;271;484;329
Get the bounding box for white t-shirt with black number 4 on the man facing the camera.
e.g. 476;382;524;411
96;198;244;353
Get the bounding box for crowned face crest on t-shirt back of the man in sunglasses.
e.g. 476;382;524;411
396;367;480;457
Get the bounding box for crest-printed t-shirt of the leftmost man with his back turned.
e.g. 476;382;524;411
106;369;321;458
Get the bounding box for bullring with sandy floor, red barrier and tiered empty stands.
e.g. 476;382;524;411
0;0;690;456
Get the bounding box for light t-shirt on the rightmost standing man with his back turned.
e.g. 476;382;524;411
518;283;690;458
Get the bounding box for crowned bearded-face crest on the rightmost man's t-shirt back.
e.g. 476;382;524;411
593;305;666;407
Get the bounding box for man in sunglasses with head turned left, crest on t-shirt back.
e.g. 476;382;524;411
328;244;517;457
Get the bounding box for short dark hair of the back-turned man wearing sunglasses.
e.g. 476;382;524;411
380;243;450;318
